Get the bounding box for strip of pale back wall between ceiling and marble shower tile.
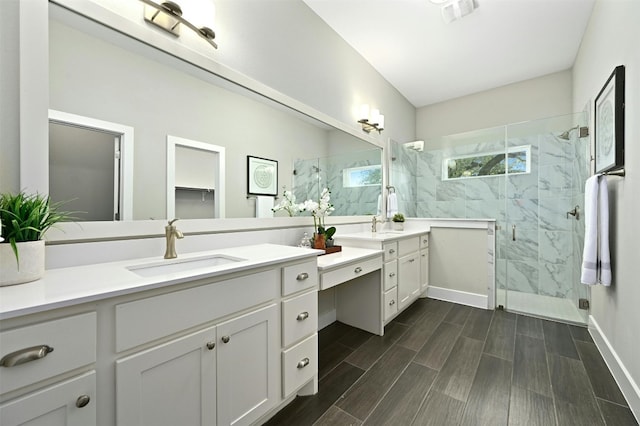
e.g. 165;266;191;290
416;70;582;141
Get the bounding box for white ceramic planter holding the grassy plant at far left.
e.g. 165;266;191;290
0;241;44;287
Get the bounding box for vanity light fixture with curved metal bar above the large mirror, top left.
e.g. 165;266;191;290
140;0;218;49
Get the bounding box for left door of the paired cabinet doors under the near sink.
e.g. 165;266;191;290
116;327;216;426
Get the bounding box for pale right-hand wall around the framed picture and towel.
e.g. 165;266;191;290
573;0;640;416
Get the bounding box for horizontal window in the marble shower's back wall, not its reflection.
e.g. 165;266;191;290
442;145;531;180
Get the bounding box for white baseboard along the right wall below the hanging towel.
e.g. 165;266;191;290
589;315;640;422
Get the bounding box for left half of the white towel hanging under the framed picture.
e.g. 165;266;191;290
580;176;598;285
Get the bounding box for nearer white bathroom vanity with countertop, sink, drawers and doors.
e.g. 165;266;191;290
0;244;318;426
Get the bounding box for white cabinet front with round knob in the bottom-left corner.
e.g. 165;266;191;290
0;371;97;426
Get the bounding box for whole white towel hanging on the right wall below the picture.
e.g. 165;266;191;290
580;176;611;286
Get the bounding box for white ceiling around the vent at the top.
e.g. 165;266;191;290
304;0;594;107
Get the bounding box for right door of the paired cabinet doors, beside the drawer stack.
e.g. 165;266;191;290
218;304;280;426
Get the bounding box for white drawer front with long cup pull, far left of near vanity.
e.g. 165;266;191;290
0;312;97;394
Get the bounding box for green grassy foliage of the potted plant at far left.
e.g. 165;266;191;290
0;192;70;260
